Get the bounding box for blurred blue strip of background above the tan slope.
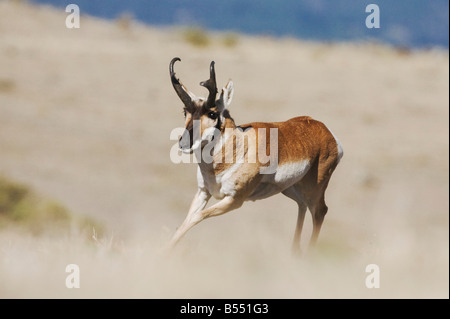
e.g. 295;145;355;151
29;0;449;48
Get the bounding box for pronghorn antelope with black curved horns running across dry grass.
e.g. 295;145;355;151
169;58;343;250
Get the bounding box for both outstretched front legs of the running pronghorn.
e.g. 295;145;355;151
170;191;243;247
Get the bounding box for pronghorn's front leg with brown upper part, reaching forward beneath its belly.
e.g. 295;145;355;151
170;197;243;247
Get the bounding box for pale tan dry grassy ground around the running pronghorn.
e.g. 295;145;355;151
0;1;449;298
